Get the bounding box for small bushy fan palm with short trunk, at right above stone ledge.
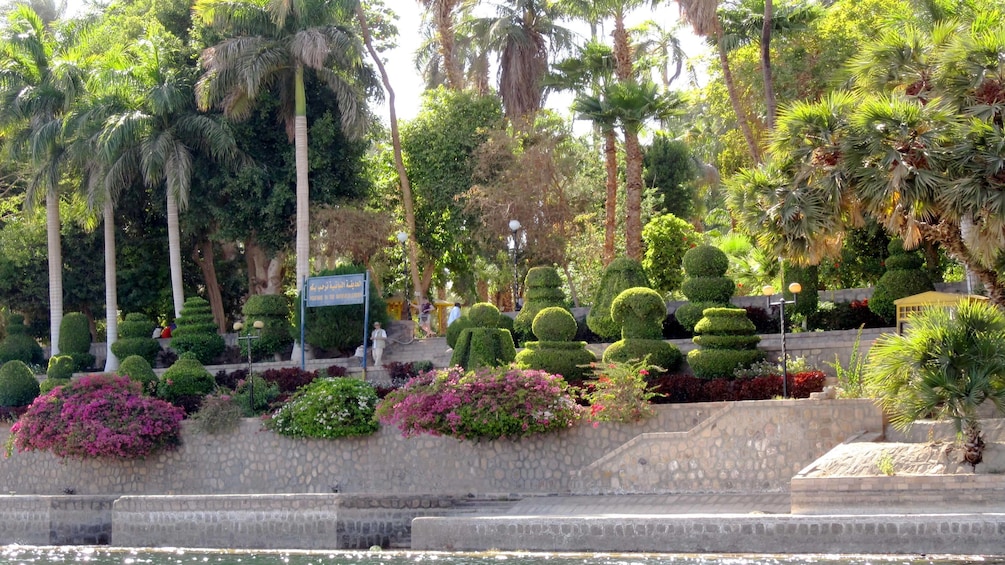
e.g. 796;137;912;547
865;301;1005;469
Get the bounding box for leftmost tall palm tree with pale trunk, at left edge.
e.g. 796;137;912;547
0;5;83;355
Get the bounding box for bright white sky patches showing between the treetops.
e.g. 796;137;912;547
67;0;707;123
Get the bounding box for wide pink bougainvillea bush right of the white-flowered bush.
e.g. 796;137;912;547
377;367;582;439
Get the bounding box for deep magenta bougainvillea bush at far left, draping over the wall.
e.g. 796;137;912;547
7;374;185;458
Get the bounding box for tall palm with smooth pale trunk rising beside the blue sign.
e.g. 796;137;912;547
195;0;378;301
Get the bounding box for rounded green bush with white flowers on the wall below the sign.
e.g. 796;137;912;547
265;377;378;439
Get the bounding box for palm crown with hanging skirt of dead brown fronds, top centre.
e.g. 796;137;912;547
471;0;572;124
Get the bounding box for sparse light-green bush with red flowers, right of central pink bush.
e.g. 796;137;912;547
583;360;656;425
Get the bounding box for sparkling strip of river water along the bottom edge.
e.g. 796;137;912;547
0;546;1005;565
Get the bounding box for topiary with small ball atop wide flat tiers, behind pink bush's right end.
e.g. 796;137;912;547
517;307;597;382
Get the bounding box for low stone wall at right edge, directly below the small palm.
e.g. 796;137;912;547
789;475;1005;515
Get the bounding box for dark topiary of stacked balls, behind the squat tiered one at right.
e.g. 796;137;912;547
673;245;737;332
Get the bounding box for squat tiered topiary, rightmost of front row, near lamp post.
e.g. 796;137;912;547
687;308;764;379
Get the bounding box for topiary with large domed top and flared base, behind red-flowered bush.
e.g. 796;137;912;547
604;287;683;371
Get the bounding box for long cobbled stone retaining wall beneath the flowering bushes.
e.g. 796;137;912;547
0;400;882;496
